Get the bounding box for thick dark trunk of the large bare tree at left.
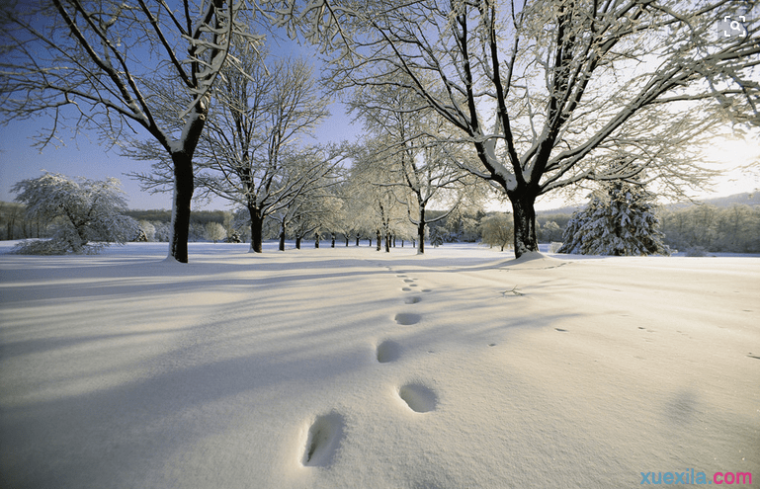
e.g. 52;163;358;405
169;151;194;263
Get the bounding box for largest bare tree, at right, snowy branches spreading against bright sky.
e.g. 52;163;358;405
275;0;760;257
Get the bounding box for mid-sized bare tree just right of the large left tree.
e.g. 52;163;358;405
203;53;348;253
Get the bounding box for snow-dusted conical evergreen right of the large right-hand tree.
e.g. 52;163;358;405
559;182;670;256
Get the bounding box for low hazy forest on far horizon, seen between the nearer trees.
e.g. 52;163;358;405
0;193;760;255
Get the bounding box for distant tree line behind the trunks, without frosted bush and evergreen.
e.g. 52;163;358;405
0;191;760;255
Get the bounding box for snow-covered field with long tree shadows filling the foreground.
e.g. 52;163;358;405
0;241;760;489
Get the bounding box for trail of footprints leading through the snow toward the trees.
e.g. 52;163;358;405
301;267;438;467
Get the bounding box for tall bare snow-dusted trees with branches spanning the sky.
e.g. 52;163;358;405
0;0;760;262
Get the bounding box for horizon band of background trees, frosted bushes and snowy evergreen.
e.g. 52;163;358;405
0;169;760;255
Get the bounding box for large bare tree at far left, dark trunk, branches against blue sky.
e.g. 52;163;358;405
0;0;259;263
